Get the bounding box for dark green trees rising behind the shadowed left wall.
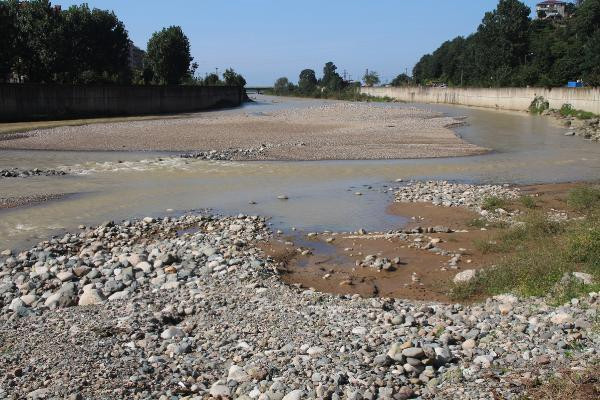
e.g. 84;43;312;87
0;0;246;86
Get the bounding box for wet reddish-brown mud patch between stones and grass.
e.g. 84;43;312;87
266;183;580;302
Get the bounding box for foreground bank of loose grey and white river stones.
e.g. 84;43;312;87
0;208;600;400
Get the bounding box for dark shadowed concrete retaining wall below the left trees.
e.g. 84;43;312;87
0;84;243;121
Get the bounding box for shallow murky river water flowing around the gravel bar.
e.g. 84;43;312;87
0;97;600;249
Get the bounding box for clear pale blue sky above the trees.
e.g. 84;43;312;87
53;0;537;85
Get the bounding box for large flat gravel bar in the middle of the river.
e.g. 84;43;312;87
0;102;487;160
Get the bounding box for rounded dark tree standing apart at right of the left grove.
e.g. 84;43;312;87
147;26;193;85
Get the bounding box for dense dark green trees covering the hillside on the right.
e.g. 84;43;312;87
413;0;600;87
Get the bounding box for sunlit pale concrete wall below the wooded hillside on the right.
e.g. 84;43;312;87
361;87;600;114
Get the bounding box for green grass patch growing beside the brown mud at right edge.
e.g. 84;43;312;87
451;187;600;303
